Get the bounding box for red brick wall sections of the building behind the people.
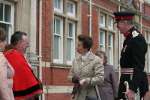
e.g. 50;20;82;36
42;0;150;100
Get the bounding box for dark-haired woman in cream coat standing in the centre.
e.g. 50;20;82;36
68;35;104;100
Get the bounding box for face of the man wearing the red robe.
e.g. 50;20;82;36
19;35;29;52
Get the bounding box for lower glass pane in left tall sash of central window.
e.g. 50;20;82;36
53;35;60;59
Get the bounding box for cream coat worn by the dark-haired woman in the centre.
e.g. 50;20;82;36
68;52;104;100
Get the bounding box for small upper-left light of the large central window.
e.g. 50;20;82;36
53;0;63;13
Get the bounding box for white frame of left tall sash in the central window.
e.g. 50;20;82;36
53;16;64;64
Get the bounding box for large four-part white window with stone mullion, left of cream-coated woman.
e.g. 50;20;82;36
53;0;79;65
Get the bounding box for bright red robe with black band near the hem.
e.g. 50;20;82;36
5;49;42;97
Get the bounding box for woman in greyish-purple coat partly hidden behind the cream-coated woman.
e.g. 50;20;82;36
96;50;118;100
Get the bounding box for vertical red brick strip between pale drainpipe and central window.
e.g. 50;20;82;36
42;0;53;61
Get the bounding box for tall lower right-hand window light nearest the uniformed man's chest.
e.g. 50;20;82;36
108;33;114;64
